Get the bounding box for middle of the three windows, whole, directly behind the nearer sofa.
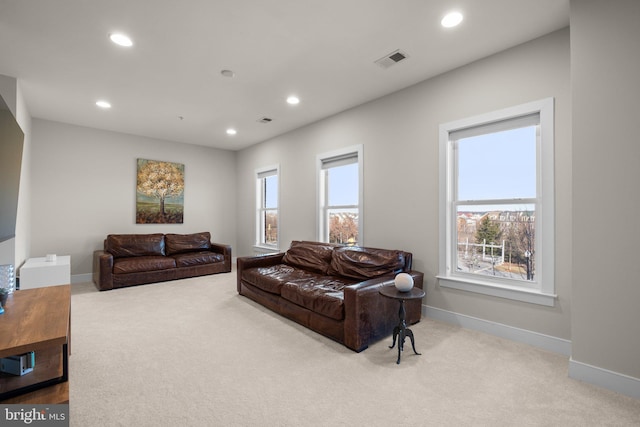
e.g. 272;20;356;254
317;145;362;245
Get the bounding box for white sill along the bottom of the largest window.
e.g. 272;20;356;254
436;276;558;307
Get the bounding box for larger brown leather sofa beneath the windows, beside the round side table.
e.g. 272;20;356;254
237;241;424;352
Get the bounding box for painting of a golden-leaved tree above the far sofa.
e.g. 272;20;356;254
136;159;184;224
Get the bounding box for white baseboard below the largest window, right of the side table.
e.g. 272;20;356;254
422;305;571;356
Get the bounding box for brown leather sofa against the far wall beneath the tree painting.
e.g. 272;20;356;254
93;232;231;291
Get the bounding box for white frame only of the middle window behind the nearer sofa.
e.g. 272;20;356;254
316;144;364;246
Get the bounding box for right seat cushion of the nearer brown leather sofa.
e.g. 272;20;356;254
280;276;350;320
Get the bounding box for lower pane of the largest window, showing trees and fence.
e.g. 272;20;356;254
456;204;536;281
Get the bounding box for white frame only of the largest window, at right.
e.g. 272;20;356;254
436;98;557;307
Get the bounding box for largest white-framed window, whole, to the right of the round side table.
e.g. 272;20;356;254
438;98;555;306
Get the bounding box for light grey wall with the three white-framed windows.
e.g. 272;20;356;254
236;29;572;339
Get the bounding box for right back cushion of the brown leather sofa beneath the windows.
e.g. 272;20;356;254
328;246;404;280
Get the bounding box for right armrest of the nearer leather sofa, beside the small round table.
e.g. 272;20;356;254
344;270;424;352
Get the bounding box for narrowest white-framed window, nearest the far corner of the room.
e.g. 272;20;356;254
256;166;280;249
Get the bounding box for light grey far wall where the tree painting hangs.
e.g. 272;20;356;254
30;119;236;280
